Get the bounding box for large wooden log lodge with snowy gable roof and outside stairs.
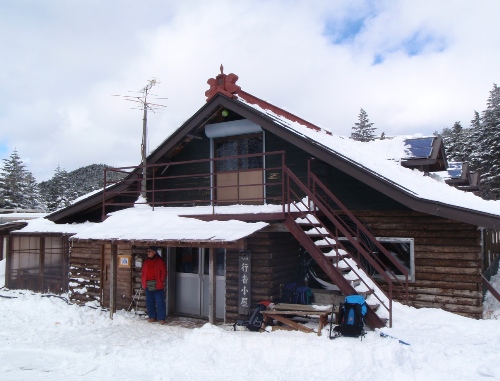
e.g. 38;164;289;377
0;69;500;327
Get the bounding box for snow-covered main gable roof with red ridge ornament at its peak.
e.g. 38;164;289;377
47;68;500;229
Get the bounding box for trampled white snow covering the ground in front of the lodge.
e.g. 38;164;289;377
0;262;500;381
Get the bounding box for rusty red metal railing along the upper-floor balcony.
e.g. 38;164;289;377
102;151;285;219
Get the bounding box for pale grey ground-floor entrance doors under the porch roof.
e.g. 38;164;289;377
175;247;226;319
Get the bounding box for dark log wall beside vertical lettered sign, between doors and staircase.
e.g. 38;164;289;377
226;232;300;323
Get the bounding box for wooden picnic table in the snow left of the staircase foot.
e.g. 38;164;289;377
261;303;338;336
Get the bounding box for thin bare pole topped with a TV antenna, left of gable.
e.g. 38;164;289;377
113;78;168;199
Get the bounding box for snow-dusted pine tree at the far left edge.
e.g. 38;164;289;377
0;150;43;210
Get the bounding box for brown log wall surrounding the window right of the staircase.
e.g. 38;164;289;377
354;211;483;319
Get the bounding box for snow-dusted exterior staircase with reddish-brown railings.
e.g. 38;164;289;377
283;168;408;328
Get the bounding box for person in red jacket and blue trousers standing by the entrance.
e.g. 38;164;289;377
141;246;167;324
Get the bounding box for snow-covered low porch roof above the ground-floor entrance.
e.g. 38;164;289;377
17;204;270;242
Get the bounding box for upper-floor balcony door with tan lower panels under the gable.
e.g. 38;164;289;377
214;134;264;204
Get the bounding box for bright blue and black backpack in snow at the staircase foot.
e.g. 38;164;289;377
330;295;368;339
